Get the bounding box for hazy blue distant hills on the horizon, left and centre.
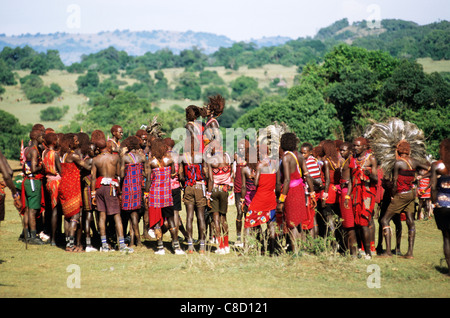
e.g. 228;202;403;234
0;30;291;65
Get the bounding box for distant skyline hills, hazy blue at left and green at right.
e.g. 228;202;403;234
0;18;450;65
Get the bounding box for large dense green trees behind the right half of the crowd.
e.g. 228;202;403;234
235;45;450;156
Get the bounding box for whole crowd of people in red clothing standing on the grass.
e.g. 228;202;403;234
1;96;450;272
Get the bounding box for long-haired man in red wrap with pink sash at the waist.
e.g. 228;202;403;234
277;133;316;253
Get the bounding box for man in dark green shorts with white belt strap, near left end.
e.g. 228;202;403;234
21;130;45;245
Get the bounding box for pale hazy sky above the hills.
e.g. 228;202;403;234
0;0;450;41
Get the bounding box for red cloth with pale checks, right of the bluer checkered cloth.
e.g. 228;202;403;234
148;167;173;208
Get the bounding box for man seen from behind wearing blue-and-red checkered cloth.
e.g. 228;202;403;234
120;136;150;246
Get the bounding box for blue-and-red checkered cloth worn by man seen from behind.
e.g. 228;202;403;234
122;163;144;210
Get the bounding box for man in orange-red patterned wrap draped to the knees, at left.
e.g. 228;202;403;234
58;133;89;252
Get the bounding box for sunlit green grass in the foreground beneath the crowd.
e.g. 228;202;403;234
0;186;450;298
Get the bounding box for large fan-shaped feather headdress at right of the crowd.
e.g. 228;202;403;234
363;118;427;175
